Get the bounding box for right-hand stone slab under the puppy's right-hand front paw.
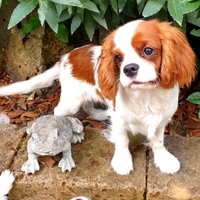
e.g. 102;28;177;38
147;136;200;200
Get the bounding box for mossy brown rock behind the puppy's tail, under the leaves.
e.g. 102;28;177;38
5;16;45;81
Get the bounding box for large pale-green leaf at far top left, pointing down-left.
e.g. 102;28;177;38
8;0;38;29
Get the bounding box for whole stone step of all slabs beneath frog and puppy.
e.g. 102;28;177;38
0;125;200;200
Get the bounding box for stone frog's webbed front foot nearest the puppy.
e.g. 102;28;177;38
58;148;75;173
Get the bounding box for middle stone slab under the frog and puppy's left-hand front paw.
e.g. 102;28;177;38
9;128;146;200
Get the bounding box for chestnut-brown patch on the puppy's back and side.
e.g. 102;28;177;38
68;45;99;85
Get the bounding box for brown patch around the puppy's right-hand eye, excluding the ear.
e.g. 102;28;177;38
131;20;162;82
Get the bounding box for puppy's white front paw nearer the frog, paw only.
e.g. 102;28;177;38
111;150;133;175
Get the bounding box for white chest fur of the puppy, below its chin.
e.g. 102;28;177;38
116;86;179;137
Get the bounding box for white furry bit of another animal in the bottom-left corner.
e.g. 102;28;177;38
0;170;15;200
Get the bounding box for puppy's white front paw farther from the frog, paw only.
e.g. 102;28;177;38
154;148;180;174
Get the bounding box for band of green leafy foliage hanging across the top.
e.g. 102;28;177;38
0;0;200;42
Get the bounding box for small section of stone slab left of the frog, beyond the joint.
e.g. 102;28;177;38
0;124;26;174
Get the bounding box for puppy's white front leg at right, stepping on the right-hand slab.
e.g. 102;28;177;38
150;124;180;174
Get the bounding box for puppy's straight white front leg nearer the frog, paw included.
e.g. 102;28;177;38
110;115;133;175
